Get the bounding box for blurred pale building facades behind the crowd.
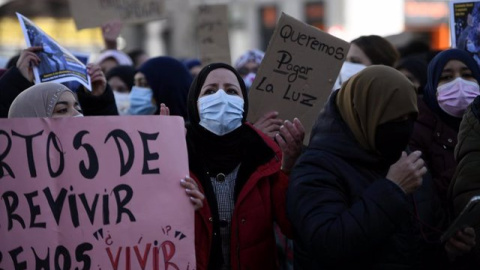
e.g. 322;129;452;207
0;0;450;66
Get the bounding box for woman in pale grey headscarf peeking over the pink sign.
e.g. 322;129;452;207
8;82;83;118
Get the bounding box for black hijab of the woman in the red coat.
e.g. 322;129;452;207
187;63;248;175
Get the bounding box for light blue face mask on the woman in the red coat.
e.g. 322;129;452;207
197;89;244;136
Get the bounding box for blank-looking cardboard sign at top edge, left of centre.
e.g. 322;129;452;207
68;0;164;30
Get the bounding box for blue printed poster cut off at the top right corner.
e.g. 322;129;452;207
449;0;480;53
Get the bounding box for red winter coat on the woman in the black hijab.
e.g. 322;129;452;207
191;126;292;270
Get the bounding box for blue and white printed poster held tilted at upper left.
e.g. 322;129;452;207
17;13;92;90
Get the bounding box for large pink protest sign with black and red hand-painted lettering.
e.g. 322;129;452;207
0;116;195;270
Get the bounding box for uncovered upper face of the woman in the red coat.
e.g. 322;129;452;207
198;68;243;99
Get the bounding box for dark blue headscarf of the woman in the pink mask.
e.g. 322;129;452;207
423;49;480;131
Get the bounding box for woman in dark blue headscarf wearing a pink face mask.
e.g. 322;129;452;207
409;49;480;213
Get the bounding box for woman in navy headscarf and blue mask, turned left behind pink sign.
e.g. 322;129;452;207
128;56;192;119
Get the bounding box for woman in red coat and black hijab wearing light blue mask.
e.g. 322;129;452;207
187;63;304;269
